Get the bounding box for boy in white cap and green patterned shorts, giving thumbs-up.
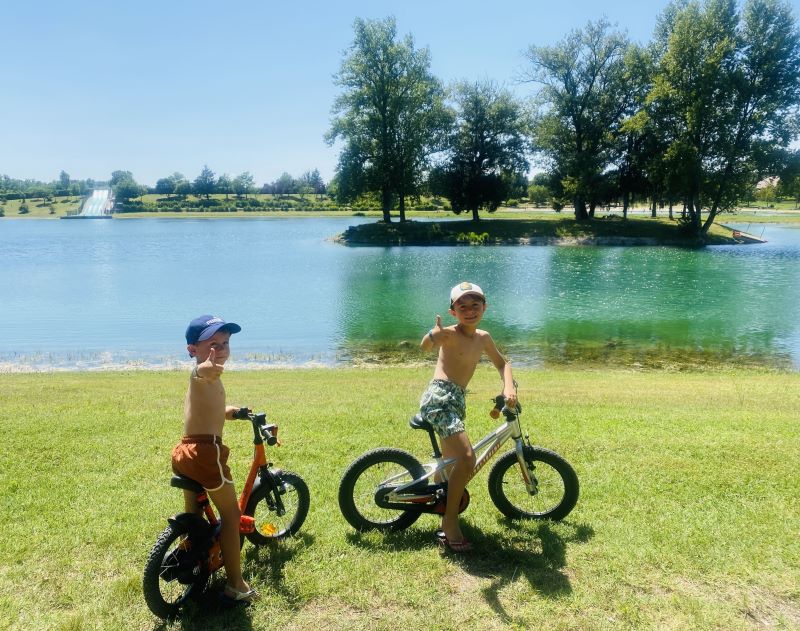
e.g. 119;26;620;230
420;282;517;552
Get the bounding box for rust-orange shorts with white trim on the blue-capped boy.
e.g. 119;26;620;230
172;434;233;491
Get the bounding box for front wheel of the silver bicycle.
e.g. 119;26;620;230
489;446;578;521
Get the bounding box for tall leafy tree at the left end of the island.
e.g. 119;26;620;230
326;18;449;223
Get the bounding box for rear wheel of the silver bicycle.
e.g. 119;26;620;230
339;448;425;532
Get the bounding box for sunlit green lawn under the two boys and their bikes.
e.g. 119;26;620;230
0;365;800;630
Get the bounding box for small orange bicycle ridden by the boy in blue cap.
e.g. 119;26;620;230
142;408;311;618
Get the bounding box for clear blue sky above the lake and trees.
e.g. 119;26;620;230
0;0;680;185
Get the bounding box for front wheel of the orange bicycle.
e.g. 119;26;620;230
244;471;311;546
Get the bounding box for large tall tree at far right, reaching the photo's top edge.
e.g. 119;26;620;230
648;0;800;236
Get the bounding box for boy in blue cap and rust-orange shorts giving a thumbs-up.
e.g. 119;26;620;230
172;315;258;602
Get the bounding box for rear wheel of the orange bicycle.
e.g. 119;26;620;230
142;523;209;619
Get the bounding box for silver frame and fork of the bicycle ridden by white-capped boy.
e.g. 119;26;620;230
390;408;536;502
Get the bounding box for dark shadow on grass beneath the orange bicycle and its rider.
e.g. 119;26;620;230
154;533;314;631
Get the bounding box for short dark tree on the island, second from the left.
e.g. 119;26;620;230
431;81;529;221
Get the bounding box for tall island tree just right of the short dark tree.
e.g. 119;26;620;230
525;20;632;220
